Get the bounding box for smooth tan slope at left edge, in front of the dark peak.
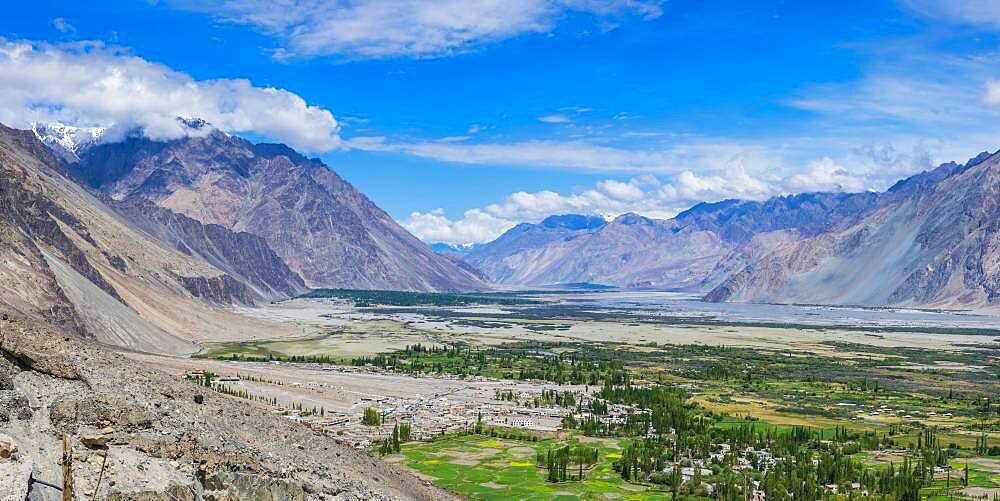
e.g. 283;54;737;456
0;126;300;353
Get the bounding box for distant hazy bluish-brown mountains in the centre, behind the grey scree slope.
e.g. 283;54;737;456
463;193;879;290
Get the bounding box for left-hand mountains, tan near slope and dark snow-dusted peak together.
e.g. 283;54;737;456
0;117;496;353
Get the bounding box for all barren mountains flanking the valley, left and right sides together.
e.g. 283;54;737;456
11;110;1000;353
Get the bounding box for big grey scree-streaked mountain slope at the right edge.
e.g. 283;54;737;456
706;151;1000;307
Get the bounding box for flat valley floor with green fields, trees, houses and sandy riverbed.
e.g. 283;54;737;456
164;291;1000;499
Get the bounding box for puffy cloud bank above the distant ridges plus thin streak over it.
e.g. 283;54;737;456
366;131;971;244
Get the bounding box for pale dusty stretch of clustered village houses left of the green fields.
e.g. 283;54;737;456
184;362;608;450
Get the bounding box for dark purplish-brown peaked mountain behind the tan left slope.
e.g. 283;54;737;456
70;125;484;291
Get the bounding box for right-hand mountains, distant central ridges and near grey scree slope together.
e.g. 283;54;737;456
452;153;1000;307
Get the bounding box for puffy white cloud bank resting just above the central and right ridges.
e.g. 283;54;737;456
392;141;952;244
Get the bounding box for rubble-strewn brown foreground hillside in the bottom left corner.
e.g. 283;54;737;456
0;314;452;501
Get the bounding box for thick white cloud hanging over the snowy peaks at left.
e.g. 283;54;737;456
0;38;340;152
